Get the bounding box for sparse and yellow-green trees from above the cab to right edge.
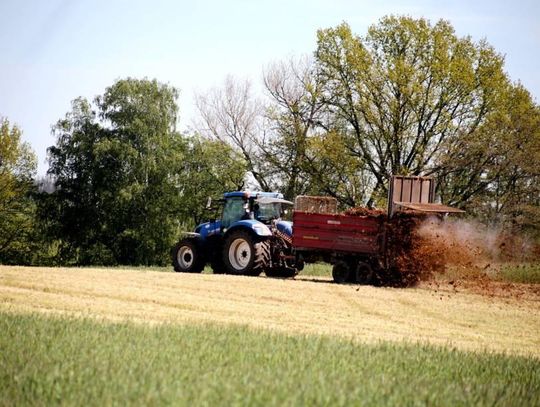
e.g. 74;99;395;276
192;16;540;236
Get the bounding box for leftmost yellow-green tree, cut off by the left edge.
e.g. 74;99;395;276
0;118;37;264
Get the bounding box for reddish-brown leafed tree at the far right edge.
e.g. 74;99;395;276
440;84;540;234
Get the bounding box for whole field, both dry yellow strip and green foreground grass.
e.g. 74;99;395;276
0;266;540;405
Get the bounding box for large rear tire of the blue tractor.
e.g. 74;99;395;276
223;230;270;276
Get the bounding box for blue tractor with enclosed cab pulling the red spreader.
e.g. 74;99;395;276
172;191;302;277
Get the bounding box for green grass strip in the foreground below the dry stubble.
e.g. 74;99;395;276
0;313;540;406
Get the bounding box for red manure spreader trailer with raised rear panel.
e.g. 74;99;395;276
292;176;463;283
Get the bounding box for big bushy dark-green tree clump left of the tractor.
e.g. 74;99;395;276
44;79;247;265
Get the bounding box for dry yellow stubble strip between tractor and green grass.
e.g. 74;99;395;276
0;266;540;357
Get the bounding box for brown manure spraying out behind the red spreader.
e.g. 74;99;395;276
336;207;523;287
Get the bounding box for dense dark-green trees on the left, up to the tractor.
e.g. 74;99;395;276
0;79;245;265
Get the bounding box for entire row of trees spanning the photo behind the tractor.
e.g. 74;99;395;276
0;17;540;265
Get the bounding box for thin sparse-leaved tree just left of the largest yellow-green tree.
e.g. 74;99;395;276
259;58;376;206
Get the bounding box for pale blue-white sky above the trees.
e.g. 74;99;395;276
0;0;540;175
